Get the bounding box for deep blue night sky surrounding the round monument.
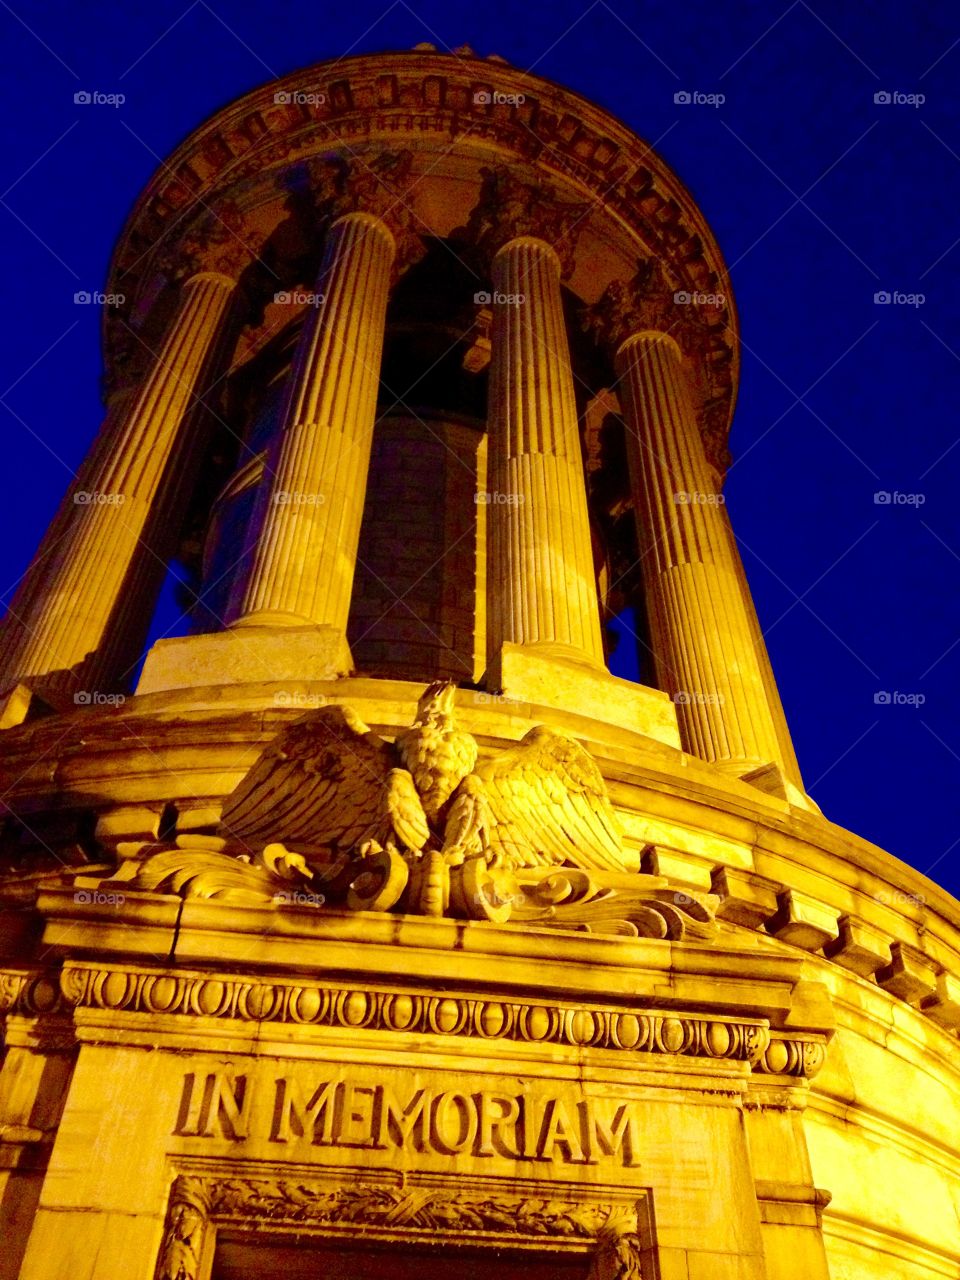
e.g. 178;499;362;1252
0;0;960;892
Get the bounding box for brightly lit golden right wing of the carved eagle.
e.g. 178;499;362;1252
475;726;632;872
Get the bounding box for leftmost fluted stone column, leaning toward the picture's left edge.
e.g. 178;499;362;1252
0;264;236;686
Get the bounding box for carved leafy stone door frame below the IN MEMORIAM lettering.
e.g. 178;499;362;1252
155;1174;645;1280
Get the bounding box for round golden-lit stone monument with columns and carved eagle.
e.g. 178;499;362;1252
0;46;960;1280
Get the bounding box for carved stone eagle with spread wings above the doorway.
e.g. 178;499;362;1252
221;682;632;870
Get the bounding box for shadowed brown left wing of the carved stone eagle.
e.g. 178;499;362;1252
220;707;396;852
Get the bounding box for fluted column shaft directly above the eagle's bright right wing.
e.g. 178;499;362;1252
488;236;603;667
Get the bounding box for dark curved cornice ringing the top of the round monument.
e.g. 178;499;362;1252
104;51;739;465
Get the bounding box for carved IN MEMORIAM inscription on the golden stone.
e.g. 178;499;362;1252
173;1071;640;1167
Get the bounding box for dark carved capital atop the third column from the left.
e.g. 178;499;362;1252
465;165;590;276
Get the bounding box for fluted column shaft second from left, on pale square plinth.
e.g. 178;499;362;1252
230;212;396;636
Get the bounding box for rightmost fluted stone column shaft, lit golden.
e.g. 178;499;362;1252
617;332;795;776
